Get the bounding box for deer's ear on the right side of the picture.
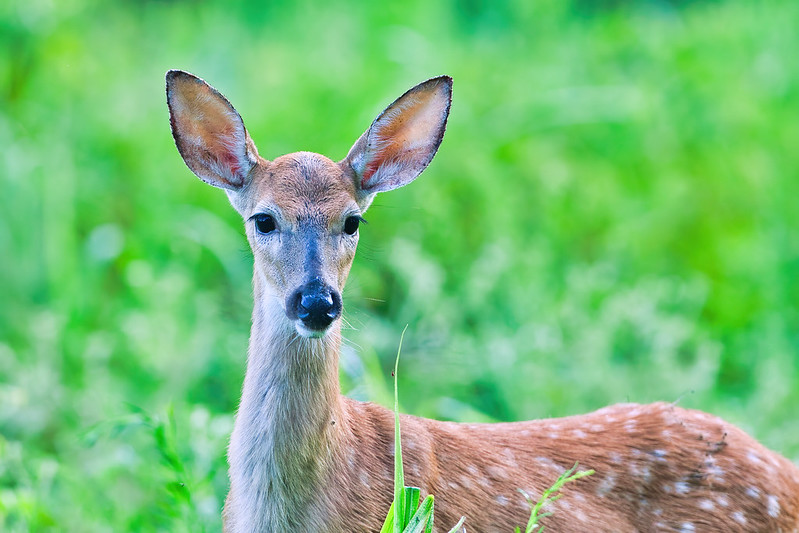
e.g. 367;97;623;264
342;76;452;204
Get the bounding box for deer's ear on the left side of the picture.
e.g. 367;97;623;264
166;70;258;190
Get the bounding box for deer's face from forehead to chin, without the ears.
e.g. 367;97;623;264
230;152;363;337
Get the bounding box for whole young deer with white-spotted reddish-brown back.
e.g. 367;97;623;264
166;70;799;533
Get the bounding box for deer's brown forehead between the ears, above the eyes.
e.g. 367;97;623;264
244;152;357;219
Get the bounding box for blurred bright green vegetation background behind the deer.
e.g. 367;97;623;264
0;0;799;532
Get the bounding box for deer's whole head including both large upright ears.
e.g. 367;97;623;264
167;70;452;337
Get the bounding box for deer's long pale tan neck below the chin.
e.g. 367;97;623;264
228;276;345;531
